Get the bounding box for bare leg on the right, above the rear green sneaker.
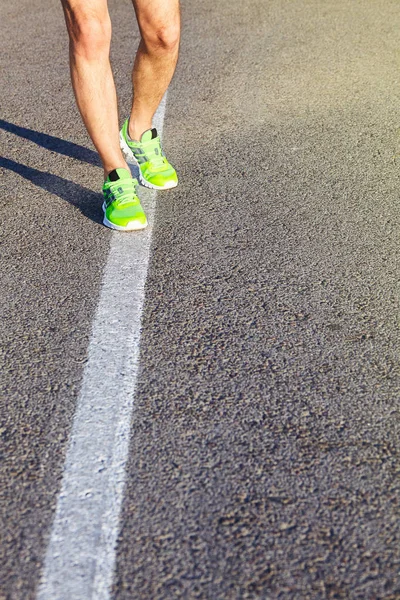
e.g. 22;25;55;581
129;0;180;140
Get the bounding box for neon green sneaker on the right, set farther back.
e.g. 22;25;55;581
120;119;178;190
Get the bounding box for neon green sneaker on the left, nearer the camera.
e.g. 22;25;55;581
103;169;147;231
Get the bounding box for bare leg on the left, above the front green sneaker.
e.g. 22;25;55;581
61;0;129;178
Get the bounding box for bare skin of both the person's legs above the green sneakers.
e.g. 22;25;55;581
62;0;180;178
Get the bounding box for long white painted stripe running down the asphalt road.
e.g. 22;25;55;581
37;97;166;600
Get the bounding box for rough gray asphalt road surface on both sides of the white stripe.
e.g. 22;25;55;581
0;0;400;600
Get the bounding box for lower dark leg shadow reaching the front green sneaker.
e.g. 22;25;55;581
0;156;103;223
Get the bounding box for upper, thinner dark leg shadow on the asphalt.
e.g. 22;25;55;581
0;119;102;167
